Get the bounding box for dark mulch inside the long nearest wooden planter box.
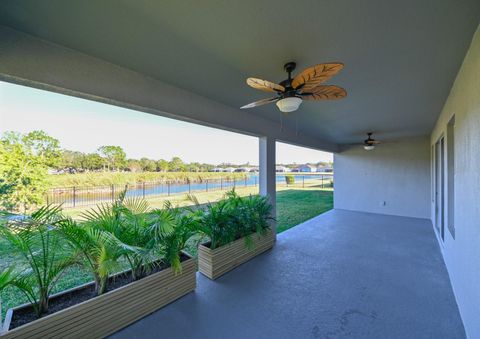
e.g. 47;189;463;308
9;253;189;330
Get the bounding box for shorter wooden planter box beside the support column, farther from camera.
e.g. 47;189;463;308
198;230;275;280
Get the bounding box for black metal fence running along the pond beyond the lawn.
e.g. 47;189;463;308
46;174;333;208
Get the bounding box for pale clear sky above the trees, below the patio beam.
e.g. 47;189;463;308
0;82;333;164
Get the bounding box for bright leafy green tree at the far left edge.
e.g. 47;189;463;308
0;131;60;212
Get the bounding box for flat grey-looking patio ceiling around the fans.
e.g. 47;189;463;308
0;0;480;144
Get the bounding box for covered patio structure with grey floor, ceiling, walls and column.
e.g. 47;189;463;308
0;0;480;338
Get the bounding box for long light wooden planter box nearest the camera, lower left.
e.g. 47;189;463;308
0;258;196;339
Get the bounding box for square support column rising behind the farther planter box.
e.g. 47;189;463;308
258;137;277;237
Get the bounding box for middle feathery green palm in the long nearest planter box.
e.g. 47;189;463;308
61;191;164;294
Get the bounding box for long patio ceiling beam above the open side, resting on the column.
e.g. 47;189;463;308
0;26;338;152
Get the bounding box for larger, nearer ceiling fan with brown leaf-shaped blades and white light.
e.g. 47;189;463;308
240;62;347;113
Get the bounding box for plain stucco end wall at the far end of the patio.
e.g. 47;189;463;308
334;137;430;218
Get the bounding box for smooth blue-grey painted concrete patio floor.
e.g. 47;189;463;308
112;210;465;339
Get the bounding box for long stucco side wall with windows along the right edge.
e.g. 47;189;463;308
431;26;480;338
